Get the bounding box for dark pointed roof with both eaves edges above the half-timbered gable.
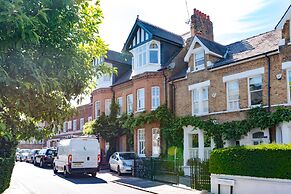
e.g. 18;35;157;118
123;18;184;50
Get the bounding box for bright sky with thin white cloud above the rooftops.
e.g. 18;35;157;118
100;0;291;51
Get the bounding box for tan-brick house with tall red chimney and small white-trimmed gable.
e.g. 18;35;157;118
169;8;291;170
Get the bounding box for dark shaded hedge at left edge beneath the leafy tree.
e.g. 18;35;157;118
0;155;15;193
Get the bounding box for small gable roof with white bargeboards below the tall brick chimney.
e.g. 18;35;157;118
184;35;227;62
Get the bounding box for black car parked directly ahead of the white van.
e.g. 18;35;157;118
34;148;57;168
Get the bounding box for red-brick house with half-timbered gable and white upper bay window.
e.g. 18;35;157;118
92;18;184;156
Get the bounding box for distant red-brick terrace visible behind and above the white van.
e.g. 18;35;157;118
46;103;92;147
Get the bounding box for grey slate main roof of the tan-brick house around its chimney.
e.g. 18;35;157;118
170;30;281;80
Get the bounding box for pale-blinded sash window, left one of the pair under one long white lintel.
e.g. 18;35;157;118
226;80;239;110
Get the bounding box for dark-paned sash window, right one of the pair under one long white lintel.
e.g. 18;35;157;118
249;75;263;106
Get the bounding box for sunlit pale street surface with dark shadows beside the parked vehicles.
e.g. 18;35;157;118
4;162;208;194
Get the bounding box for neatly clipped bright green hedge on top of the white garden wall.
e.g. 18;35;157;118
209;144;291;179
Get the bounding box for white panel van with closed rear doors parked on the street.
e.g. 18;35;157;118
53;137;100;177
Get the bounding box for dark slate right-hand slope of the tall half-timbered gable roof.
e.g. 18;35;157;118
137;19;184;45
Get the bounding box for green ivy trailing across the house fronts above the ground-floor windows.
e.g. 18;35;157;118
120;106;291;148
